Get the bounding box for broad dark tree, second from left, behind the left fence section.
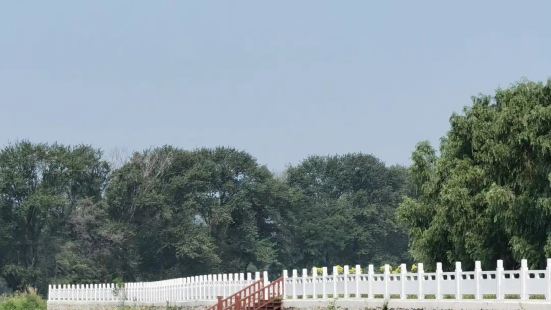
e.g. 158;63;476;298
107;147;294;279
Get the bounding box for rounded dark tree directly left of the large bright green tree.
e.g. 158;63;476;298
286;154;407;266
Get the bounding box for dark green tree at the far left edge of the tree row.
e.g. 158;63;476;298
0;142;109;292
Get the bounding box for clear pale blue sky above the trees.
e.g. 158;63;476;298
0;0;551;172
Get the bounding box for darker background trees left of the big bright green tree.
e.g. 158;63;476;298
0;142;407;293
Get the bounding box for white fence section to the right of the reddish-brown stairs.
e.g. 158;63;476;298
283;259;551;302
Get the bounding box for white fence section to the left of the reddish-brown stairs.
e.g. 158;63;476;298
48;271;268;305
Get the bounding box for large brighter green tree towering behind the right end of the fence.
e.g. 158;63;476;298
399;81;551;267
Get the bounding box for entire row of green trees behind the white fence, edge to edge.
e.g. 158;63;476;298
0;78;551;293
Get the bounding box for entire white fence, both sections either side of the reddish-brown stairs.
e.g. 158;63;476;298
48;259;551;308
